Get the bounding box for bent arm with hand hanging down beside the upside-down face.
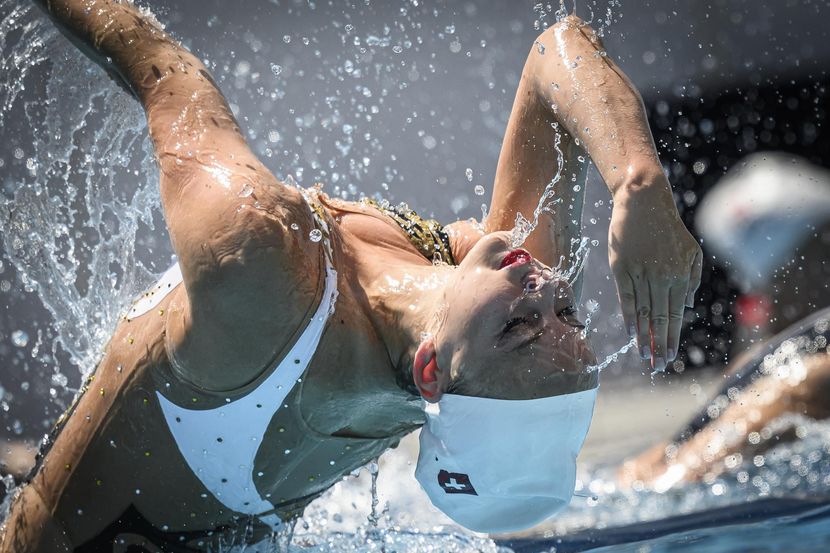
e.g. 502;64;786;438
486;16;702;370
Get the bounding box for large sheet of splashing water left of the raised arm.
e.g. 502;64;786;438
0;42;159;374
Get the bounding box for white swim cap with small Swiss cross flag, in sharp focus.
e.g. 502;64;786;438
415;388;597;533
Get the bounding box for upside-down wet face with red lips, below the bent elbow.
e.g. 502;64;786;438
436;232;597;399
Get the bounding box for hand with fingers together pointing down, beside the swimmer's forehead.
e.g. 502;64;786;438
608;178;703;371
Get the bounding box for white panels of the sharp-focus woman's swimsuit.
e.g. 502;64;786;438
127;201;337;529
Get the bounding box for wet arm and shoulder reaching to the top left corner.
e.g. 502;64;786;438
37;0;328;390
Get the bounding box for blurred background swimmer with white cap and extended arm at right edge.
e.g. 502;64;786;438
621;152;830;491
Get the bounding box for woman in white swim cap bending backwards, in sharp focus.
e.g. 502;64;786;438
0;0;701;553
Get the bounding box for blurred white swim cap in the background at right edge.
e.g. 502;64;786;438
696;152;830;285
